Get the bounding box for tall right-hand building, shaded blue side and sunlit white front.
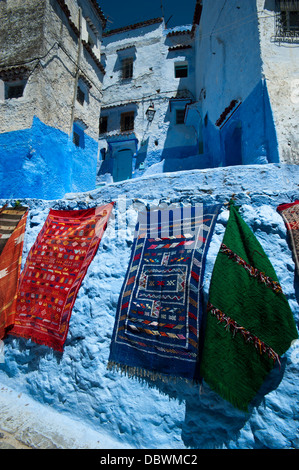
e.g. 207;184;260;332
194;0;299;167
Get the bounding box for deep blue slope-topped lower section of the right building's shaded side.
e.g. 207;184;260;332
203;80;279;168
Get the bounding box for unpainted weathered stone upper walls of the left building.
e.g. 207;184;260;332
0;0;103;140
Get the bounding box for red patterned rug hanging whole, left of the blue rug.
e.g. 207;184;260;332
9;203;114;351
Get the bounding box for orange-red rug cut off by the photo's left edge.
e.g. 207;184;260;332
0;207;28;339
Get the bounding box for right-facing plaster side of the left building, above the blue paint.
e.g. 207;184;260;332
43;0;103;139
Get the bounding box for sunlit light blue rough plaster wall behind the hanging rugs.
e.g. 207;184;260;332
0;164;299;449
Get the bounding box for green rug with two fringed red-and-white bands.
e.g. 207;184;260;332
201;202;298;411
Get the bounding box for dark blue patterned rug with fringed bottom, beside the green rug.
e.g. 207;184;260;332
108;204;221;381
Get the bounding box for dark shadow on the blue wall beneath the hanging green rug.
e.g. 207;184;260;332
132;352;286;449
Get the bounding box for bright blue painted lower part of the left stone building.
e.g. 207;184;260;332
0;117;98;199
